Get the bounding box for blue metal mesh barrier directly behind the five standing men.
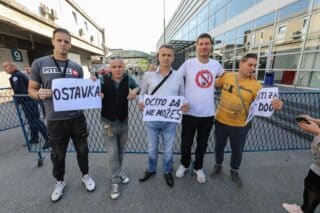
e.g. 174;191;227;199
6;92;320;156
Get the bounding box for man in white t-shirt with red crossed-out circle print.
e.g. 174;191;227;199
176;33;224;183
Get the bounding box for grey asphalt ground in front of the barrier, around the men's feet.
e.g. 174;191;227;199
0;128;320;213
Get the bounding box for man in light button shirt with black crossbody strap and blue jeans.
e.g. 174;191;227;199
139;44;189;187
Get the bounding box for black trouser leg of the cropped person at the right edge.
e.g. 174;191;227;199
301;169;320;213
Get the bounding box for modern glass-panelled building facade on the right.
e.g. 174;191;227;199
157;0;320;89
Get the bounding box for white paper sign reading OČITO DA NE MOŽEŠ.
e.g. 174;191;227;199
143;95;184;123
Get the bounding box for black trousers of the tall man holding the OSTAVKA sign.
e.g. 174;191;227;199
48;114;89;181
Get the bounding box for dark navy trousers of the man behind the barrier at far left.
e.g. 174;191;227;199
19;97;48;143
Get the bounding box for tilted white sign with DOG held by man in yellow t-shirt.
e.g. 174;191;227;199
246;87;279;123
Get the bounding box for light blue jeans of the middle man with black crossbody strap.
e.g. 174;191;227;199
146;121;177;174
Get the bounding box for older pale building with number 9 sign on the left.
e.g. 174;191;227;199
0;0;106;87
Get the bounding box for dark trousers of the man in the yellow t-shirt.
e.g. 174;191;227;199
214;120;250;171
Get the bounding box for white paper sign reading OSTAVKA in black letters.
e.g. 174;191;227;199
52;78;101;112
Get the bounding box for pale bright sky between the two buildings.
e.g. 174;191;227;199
76;0;181;53
